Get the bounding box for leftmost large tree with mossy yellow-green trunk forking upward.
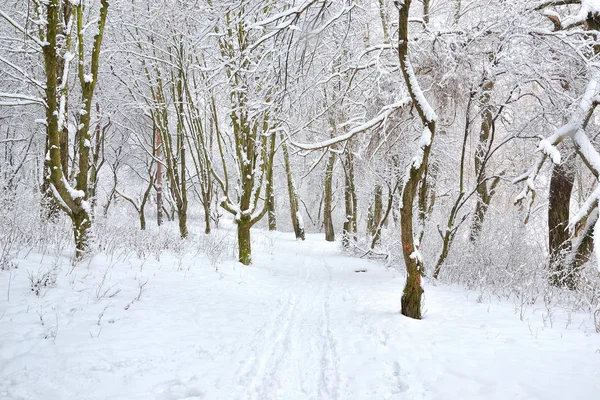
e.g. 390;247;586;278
1;0;108;259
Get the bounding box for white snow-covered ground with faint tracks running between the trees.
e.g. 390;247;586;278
0;223;600;400
